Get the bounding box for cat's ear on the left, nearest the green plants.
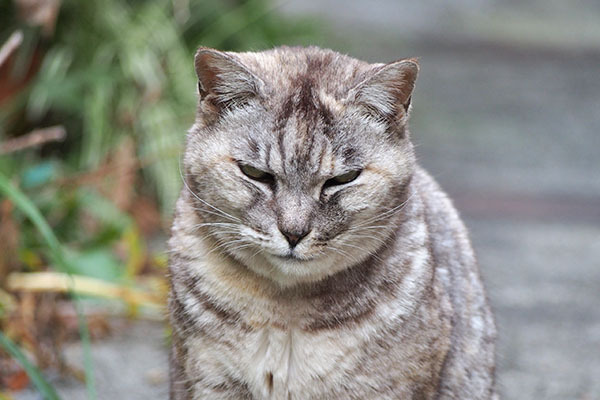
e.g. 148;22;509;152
195;47;261;113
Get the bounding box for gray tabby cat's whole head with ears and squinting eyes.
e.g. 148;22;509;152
184;47;418;286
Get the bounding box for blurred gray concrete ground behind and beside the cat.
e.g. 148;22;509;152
17;0;600;400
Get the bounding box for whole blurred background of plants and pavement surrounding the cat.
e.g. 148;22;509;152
0;0;600;400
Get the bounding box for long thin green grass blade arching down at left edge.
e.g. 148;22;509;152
0;174;96;400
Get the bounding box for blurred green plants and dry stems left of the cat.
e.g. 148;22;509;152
0;0;318;398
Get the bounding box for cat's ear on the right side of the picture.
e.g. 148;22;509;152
350;58;419;120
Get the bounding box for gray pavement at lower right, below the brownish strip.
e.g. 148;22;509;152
466;218;600;400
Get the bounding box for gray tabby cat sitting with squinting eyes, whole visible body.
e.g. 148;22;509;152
169;47;496;400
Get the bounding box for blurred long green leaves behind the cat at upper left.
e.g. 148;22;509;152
0;0;322;213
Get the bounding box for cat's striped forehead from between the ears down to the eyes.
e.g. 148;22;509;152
213;47;396;176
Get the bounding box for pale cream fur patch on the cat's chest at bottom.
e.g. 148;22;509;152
217;327;364;399
